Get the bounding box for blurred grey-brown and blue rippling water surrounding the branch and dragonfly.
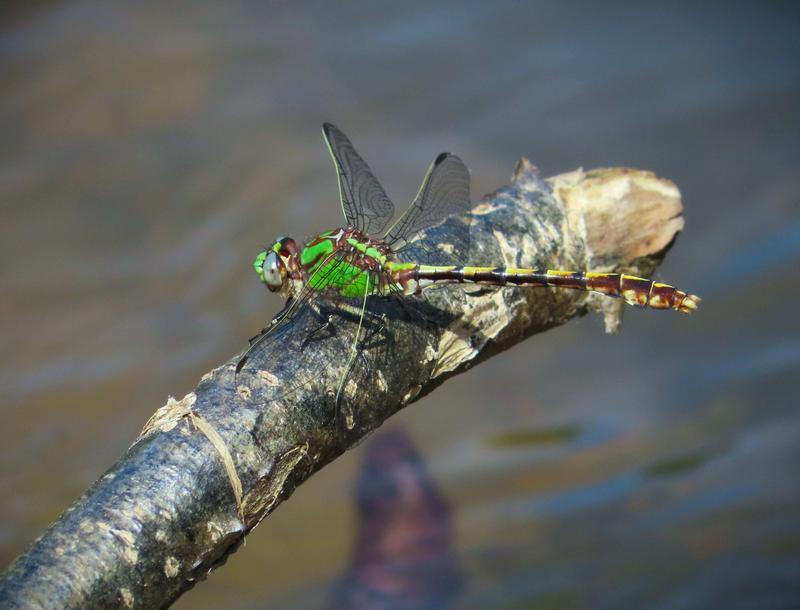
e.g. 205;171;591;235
0;1;800;609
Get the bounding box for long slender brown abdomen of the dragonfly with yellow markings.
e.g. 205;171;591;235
414;265;700;313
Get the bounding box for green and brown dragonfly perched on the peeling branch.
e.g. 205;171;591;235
235;123;700;428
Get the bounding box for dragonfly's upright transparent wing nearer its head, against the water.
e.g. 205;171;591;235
322;123;394;235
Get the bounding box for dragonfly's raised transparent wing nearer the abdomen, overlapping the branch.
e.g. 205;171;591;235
384;153;470;265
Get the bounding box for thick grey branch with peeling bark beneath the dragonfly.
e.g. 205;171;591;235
0;159;683;608
